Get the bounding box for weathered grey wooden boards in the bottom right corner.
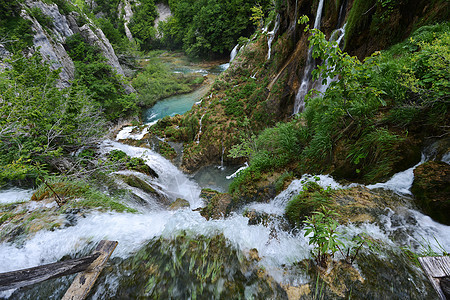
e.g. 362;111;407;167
419;256;450;300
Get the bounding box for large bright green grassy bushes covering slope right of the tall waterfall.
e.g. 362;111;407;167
229;21;450;192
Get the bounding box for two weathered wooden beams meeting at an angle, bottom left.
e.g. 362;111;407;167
0;240;118;300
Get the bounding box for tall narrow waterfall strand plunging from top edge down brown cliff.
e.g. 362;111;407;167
294;0;323;114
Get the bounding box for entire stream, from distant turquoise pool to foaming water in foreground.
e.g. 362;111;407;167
0;59;450;299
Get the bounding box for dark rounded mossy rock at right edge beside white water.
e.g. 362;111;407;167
411;161;450;225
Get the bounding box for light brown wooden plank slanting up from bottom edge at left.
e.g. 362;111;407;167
61;240;118;300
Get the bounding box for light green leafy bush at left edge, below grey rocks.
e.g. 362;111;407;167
0;52;105;180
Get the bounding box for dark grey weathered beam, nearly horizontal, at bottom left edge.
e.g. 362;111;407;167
0;253;100;291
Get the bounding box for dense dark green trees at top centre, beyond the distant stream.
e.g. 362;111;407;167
160;0;269;57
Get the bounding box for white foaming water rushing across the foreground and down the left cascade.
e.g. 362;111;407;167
0;141;450;297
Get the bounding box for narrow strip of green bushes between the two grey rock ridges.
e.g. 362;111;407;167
66;34;138;120
